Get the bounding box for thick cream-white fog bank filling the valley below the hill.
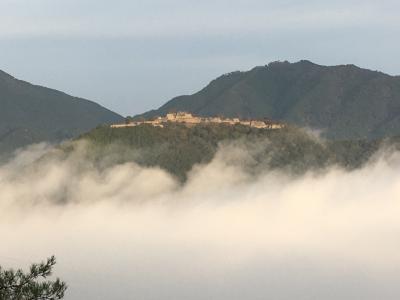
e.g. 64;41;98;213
0;145;400;300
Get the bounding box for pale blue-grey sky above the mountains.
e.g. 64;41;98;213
0;0;400;115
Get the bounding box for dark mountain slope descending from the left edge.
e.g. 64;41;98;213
0;71;123;154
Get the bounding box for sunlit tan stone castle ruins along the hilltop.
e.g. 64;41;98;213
111;112;285;129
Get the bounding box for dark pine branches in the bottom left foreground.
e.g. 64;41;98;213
0;256;67;300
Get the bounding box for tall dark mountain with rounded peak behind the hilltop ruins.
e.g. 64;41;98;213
136;60;400;139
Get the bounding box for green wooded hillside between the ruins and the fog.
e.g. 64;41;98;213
75;124;388;181
